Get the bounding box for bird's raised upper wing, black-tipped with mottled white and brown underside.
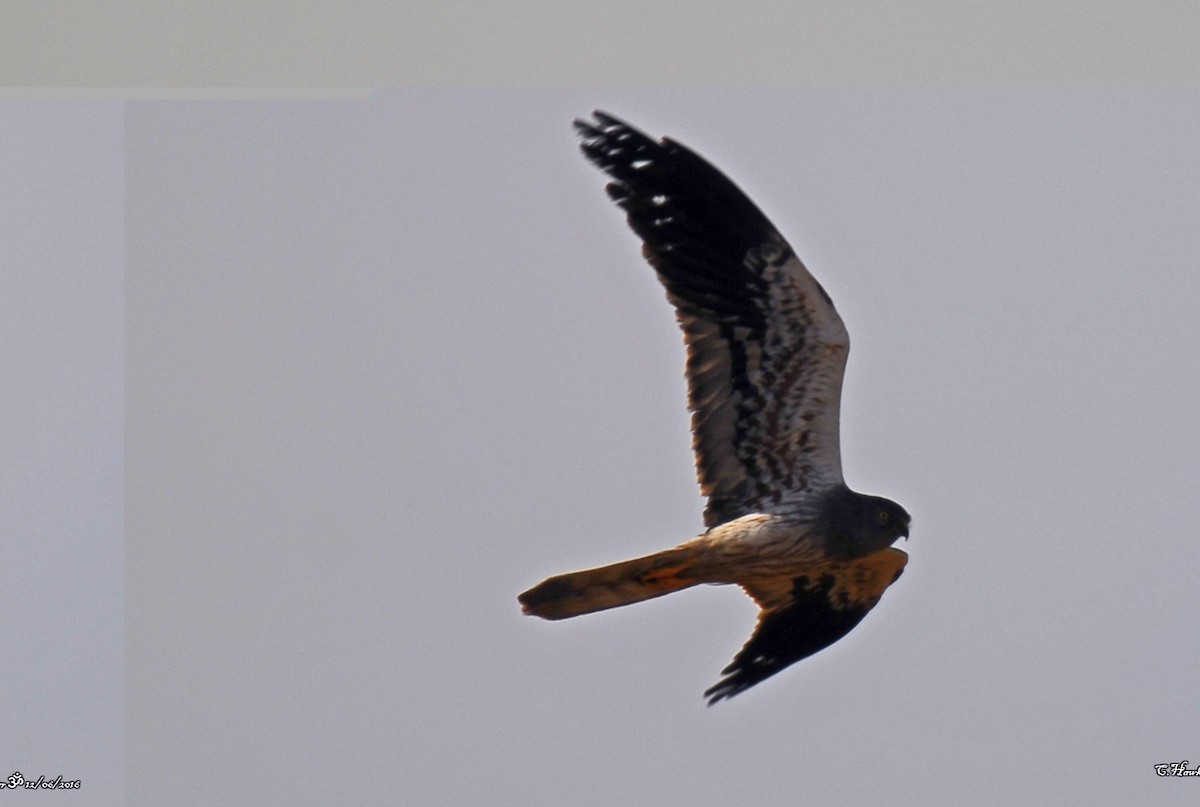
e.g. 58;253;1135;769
575;112;850;528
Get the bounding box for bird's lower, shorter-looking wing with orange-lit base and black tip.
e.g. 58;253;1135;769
704;546;908;706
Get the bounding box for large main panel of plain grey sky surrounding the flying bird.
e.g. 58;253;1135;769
126;90;1200;805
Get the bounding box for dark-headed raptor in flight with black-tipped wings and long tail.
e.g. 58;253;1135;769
517;110;910;705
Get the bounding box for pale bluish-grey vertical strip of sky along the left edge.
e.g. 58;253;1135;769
0;102;125;805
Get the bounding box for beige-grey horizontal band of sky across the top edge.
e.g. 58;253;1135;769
0;0;1200;88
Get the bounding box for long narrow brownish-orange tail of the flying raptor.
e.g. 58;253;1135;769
517;546;702;620
